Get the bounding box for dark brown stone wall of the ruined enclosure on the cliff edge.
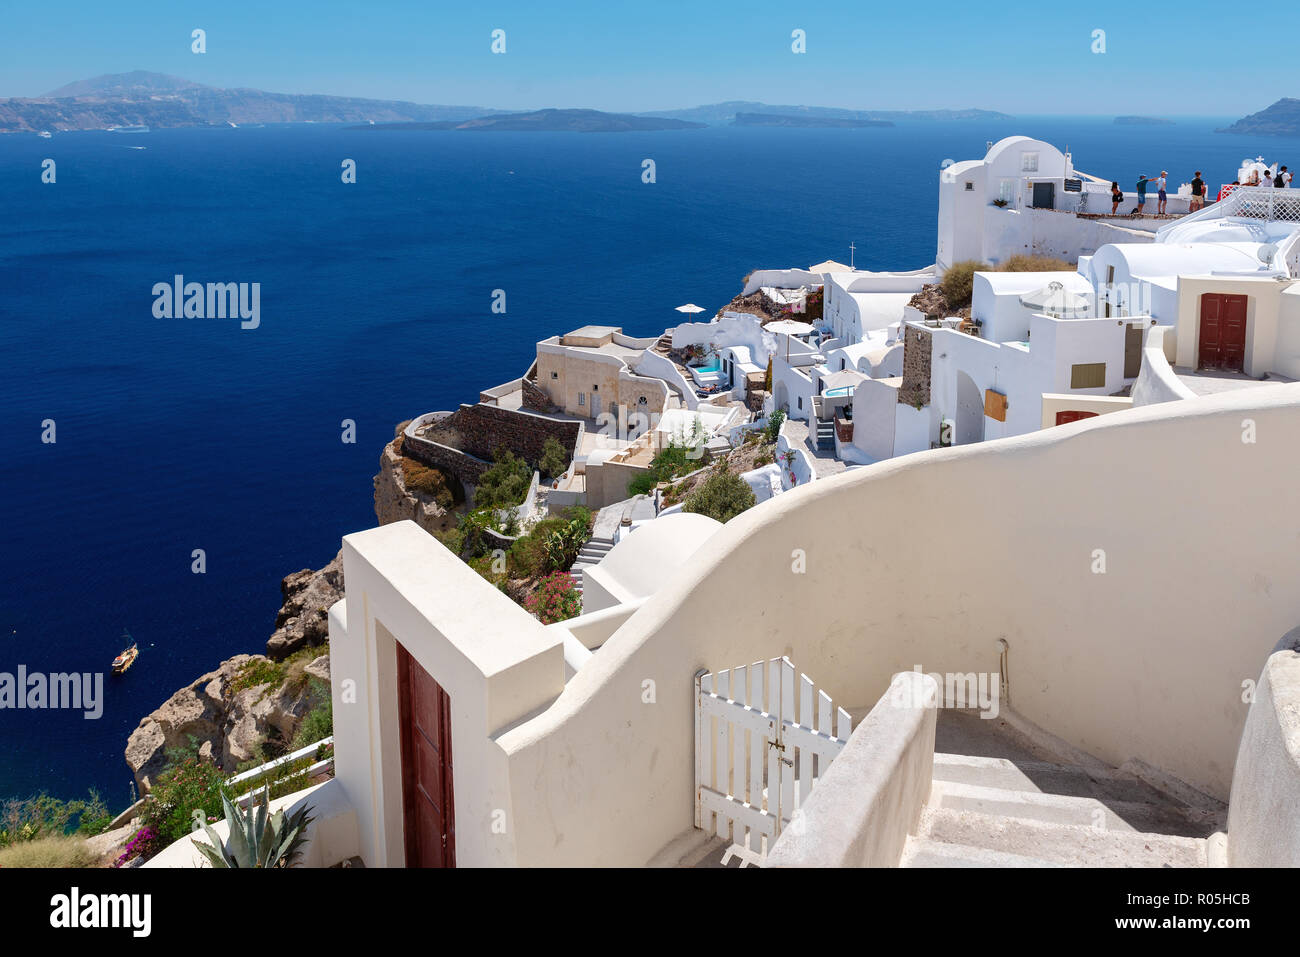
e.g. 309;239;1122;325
403;404;582;485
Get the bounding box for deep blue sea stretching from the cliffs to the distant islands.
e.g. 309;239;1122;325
0;117;1300;810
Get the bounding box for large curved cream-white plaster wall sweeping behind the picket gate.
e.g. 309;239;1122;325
497;385;1300;865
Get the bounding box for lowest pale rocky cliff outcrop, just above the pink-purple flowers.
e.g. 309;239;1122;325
126;654;329;793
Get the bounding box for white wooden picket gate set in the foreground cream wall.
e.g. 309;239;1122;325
696;658;852;865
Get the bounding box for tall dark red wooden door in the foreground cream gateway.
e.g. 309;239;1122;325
398;645;456;867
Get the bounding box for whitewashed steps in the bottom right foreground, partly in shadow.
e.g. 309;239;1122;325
900;753;1222;867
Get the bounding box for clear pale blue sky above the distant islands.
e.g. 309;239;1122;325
0;0;1300;116
